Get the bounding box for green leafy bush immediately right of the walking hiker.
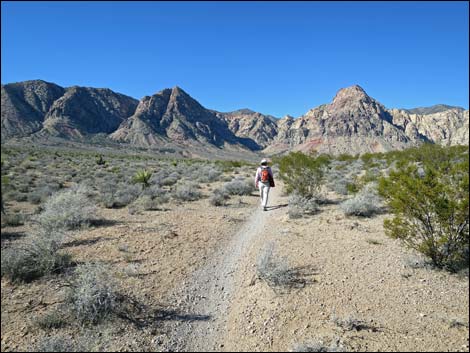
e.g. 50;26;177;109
277;152;330;197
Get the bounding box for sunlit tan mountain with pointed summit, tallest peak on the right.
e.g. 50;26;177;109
268;85;416;154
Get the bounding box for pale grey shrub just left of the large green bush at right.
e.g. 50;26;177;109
340;184;381;217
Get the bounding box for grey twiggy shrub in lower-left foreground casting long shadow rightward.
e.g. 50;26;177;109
67;263;119;325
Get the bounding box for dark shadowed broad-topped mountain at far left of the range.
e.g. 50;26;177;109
2;80;138;140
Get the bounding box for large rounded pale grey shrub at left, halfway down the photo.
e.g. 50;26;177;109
34;186;96;230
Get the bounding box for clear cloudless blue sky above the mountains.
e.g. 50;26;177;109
1;1;469;116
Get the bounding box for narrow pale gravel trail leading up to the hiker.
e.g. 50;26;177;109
164;187;283;352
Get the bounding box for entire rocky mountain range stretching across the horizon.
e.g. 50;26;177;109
1;80;469;154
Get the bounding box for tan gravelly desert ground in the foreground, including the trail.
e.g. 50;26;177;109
2;180;469;351
